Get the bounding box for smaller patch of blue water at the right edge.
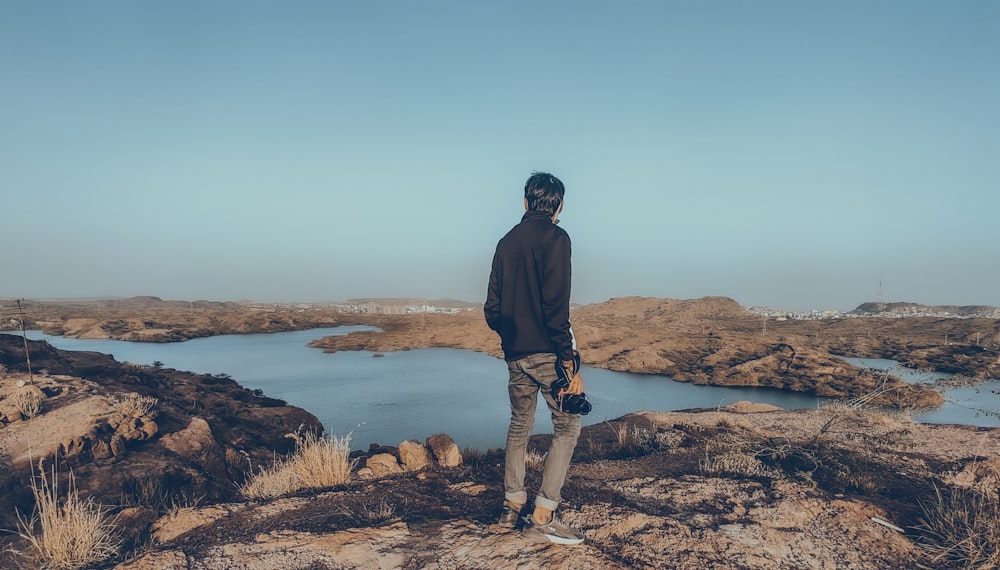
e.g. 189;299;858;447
844;358;1000;427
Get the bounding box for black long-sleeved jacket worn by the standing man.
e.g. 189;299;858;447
483;212;573;361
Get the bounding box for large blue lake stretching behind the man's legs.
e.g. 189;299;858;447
11;326;1000;449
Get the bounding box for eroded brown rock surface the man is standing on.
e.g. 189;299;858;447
119;406;1000;570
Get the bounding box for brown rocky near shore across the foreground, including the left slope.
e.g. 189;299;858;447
0;337;1000;569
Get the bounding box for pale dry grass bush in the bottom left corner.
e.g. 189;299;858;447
18;463;121;569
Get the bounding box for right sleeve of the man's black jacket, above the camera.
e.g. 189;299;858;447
541;227;573;360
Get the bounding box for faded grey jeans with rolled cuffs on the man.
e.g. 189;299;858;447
504;353;580;511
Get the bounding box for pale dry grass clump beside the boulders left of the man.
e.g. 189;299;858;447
238;433;357;499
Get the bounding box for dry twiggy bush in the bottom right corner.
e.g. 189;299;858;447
914;487;1000;570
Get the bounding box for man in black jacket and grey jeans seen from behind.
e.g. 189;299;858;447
483;172;584;544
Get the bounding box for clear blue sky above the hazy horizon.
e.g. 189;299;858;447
0;0;1000;309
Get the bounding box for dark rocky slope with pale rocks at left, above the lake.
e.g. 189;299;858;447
0;334;322;556
